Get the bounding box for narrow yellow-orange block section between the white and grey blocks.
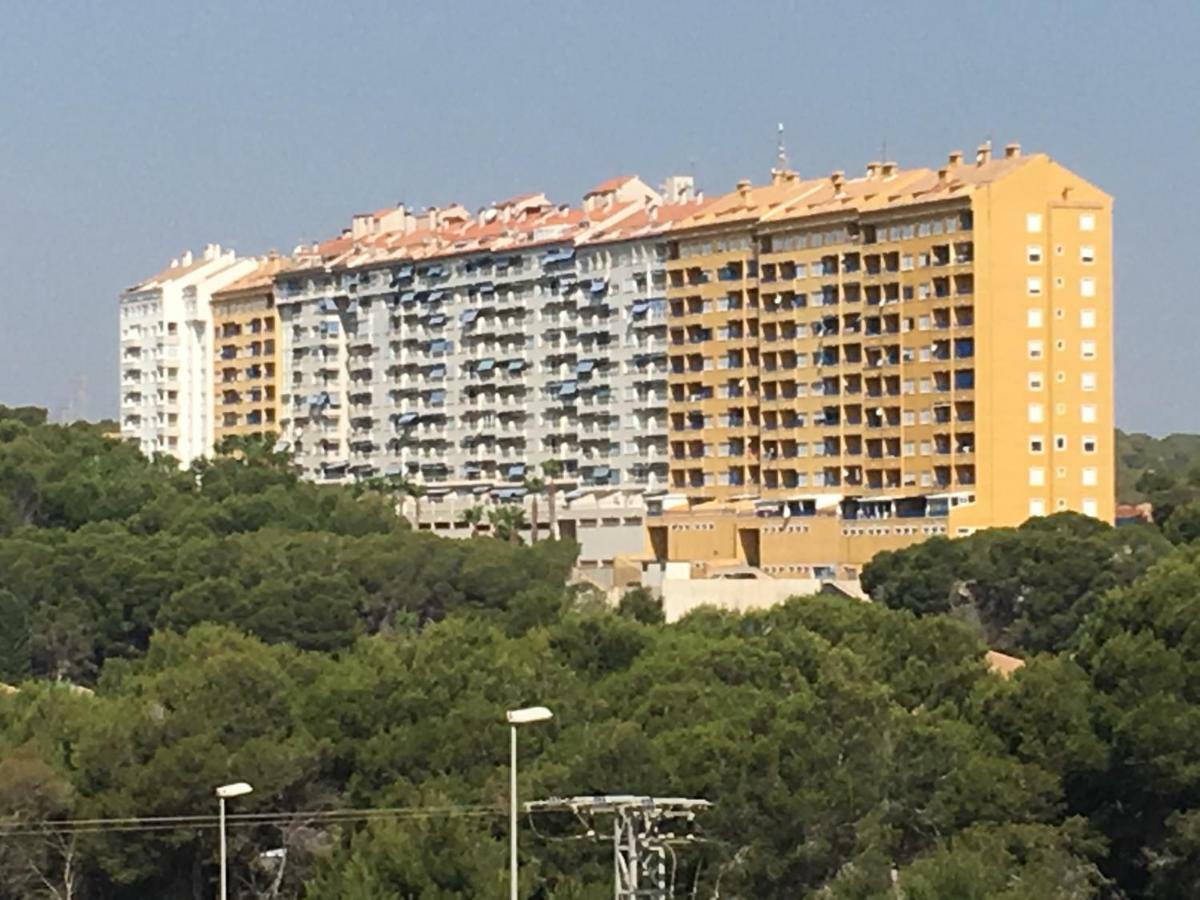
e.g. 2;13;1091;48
212;254;287;444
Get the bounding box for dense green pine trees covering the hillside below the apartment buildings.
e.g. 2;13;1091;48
0;410;1200;900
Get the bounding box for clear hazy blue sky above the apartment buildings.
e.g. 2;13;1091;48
0;0;1200;433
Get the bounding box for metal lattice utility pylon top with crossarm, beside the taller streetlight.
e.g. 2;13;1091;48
526;794;712;900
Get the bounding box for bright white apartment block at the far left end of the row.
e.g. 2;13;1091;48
119;244;254;466
